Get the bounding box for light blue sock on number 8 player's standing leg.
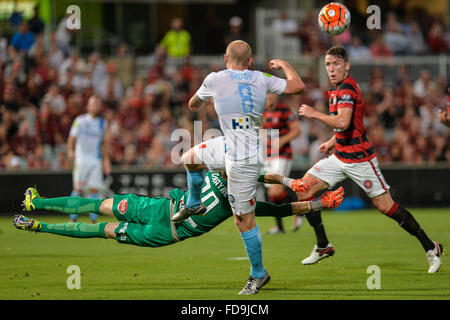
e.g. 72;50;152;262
241;226;266;278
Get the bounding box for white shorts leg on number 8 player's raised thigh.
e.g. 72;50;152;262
194;136;225;171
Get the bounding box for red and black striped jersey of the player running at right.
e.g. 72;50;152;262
328;76;375;163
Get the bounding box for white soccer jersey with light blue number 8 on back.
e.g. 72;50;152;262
196;69;286;161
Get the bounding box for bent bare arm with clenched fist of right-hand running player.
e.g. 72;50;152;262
298;104;353;130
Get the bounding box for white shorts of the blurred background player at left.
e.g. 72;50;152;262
72;160;103;189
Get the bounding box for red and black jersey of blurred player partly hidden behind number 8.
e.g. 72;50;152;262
262;102;298;159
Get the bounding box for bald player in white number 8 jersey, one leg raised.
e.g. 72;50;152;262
172;40;304;294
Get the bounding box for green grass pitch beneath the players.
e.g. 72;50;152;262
0;209;450;300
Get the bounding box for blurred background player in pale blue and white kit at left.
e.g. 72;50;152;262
67;95;111;223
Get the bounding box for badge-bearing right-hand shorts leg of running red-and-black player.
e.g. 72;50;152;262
344;158;390;199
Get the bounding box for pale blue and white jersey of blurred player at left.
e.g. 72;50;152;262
70;113;107;162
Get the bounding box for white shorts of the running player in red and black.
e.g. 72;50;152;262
307;154;391;198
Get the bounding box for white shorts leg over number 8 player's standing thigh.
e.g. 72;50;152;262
225;158;262;216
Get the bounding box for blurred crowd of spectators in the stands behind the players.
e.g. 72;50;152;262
0;6;450;170
